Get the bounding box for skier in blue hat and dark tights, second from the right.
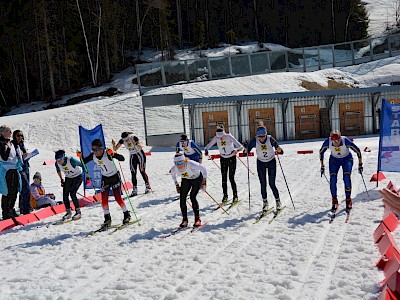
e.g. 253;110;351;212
244;126;283;211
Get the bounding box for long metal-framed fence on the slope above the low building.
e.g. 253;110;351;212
136;34;400;94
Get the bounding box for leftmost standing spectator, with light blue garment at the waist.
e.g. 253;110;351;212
0;125;22;220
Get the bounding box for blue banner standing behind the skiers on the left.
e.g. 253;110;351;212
79;124;106;190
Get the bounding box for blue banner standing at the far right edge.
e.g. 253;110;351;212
378;99;400;172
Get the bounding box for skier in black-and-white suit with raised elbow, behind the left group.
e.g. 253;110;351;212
111;131;151;197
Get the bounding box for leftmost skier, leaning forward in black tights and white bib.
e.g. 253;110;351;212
55;150;83;221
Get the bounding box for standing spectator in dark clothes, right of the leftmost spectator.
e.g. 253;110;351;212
11;130;31;215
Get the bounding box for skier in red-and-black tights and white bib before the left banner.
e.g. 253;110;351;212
77;139;131;229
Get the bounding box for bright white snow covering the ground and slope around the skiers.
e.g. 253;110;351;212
0;50;400;299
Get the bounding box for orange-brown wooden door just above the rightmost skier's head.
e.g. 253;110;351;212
339;102;365;136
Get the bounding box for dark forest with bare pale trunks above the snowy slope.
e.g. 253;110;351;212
0;0;368;109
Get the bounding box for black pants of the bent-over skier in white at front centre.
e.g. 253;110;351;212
180;174;203;219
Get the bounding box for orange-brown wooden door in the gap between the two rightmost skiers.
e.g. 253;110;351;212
294;105;321;140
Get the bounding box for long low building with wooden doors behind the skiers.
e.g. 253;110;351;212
182;86;400;146
